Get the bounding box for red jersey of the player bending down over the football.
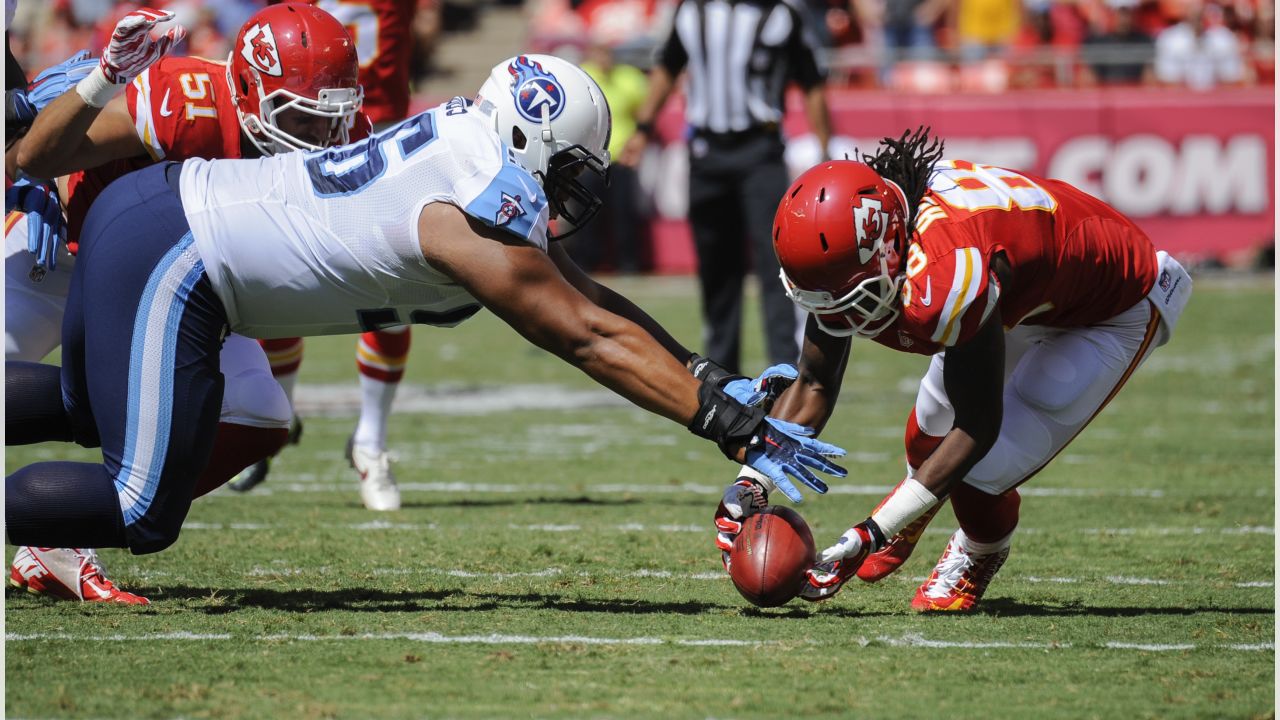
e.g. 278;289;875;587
876;160;1156;355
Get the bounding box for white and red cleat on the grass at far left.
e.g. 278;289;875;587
9;547;151;605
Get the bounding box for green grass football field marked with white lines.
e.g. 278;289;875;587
5;277;1276;719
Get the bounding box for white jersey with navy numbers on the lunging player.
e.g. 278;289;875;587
179;97;548;338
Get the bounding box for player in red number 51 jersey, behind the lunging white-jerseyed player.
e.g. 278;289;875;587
5;3;369;603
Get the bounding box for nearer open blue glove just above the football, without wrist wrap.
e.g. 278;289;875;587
746;418;849;502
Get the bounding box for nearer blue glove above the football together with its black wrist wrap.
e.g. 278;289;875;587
689;382;849;502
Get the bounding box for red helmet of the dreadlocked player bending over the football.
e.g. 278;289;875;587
773;160;909;337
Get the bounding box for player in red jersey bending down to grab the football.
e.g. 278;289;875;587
717;129;1192;612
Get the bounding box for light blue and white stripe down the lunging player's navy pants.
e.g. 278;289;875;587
115;232;205;525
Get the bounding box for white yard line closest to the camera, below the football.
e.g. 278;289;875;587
5;632;1275;652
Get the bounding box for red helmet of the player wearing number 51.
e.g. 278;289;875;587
227;3;365;155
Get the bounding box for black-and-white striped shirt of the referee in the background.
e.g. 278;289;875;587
658;0;826;133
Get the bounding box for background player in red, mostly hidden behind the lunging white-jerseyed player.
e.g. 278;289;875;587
238;0;417;510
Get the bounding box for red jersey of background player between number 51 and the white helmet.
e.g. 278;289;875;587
316;0;417;123
